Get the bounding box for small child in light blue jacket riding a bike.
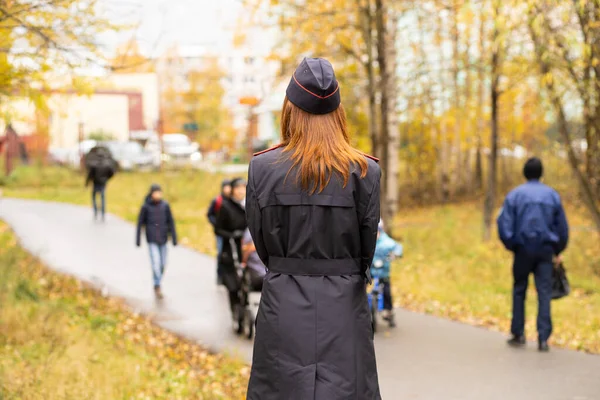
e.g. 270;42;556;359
371;221;404;328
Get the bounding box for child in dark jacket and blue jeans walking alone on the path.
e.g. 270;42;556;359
135;184;177;299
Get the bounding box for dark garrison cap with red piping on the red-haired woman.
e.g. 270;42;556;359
286;58;341;114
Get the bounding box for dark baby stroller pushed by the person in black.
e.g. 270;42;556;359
230;234;262;339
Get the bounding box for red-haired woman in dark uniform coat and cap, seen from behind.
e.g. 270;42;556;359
246;59;381;400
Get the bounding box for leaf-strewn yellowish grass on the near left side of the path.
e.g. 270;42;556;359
0;222;248;400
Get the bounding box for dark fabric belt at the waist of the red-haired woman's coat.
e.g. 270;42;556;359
269;256;364;276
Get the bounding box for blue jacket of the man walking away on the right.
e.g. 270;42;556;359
498;181;569;255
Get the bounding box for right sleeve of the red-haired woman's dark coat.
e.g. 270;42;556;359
360;168;381;280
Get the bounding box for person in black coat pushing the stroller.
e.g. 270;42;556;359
215;178;247;317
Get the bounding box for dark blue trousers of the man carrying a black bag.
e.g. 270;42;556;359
511;251;554;341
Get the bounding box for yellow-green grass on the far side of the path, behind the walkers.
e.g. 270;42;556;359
4;164;600;353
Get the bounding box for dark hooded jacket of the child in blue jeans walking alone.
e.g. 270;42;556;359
136;196;177;246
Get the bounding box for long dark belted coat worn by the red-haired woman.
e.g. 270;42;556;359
246;148;381;400
